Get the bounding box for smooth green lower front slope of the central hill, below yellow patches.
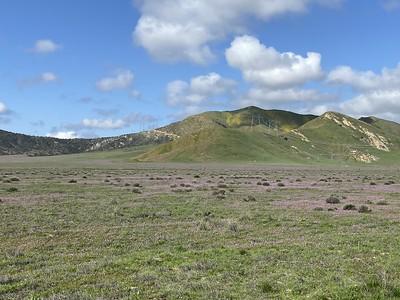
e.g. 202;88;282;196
137;128;306;163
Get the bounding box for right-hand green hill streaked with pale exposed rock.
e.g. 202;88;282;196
290;112;400;163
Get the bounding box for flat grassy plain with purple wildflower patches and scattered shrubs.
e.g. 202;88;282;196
0;154;400;299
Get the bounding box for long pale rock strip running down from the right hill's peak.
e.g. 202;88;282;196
323;113;390;152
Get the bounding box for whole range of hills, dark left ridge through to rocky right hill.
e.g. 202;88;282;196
0;106;400;164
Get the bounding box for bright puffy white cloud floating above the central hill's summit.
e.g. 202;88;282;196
226;35;323;89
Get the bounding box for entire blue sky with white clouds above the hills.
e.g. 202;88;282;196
0;0;400;138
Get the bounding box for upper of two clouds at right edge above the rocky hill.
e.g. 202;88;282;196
327;64;400;91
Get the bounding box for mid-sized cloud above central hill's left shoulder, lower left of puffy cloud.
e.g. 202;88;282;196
167;73;236;106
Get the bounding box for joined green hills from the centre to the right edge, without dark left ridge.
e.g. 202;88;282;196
135;107;400;163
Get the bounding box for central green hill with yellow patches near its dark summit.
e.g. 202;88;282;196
137;107;317;162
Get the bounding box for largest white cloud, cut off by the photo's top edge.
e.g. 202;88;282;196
133;0;341;64
